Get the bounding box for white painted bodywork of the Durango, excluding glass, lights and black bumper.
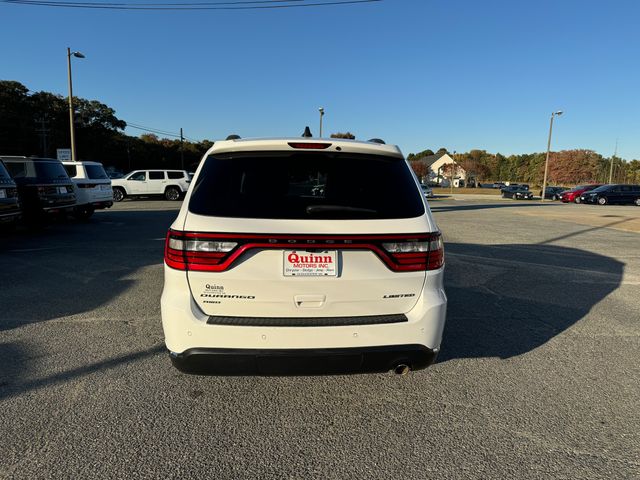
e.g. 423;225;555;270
161;138;447;353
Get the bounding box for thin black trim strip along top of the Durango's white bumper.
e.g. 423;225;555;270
207;314;409;327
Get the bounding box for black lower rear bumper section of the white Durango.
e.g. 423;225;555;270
170;345;437;375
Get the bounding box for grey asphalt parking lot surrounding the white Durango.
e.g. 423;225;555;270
0;198;640;479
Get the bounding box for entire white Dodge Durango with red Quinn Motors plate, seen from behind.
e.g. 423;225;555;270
161;138;447;375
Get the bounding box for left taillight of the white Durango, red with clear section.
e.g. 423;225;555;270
164;230;237;271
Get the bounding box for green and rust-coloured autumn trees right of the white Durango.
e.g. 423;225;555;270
407;148;640;186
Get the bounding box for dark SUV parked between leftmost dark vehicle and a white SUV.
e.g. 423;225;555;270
0;156;76;223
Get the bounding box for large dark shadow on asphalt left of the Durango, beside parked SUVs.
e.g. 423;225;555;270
0;210;177;332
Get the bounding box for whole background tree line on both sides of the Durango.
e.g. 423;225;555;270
0;80;640;186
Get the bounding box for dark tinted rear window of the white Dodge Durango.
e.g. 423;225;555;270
189;152;424;219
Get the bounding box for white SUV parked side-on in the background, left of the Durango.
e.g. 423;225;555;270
111;170;191;202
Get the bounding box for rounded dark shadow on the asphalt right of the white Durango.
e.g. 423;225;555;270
438;243;624;362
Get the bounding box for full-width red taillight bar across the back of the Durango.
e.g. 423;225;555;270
164;230;444;272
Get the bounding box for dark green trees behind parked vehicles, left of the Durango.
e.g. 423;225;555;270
0;80;213;172
